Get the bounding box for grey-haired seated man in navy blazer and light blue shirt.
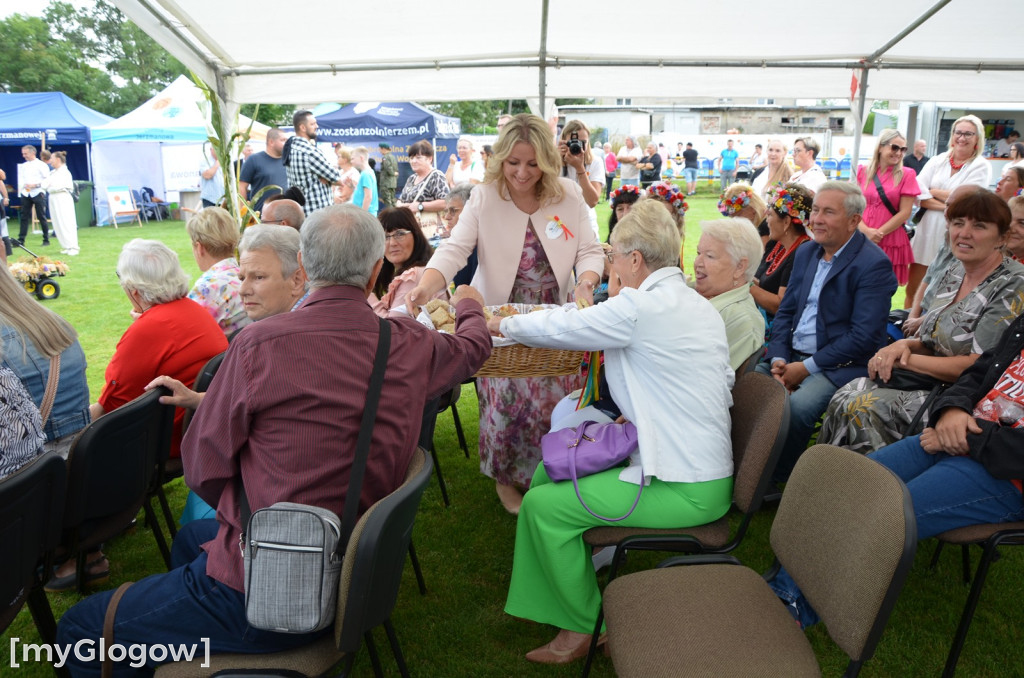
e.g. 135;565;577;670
758;181;896;481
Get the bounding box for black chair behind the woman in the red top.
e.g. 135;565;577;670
62;387;174;593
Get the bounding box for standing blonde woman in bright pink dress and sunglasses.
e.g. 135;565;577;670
857;129;921;285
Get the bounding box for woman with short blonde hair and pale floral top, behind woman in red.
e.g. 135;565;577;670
185;207;251;337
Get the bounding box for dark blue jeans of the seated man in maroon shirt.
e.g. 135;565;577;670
57;520;333;678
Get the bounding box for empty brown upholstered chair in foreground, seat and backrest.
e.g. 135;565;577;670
604;444;916;678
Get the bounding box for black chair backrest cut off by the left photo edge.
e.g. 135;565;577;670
0;452;68;631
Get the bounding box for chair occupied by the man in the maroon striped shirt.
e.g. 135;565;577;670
157;448;431;678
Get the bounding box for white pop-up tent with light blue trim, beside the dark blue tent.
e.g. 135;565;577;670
91;76;269;223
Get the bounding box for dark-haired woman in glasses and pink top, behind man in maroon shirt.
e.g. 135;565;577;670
367;207;447;317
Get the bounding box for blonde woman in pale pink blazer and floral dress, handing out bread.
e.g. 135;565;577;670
407;114;604;514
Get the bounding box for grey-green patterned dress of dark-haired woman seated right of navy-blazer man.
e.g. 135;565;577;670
818;258;1024;454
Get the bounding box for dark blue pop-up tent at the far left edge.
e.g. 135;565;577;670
0;92;113;188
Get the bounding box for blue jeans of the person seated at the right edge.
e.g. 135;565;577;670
868;435;1024;539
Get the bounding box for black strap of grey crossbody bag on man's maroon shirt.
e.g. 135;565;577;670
238;317;391;557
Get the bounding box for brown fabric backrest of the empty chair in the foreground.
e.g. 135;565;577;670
771;444;918;663
